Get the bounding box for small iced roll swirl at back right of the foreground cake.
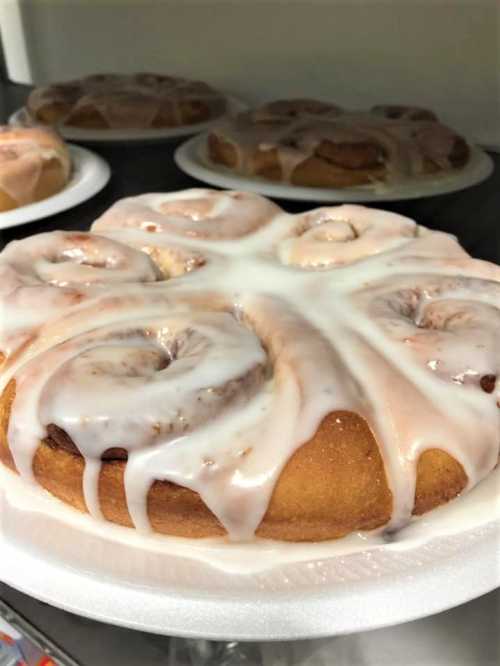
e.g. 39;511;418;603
277;205;419;269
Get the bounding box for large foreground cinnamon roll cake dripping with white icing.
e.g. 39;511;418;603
0;189;500;541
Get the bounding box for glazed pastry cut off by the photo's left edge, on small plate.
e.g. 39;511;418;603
0;126;71;212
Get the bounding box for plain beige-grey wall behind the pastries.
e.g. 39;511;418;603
0;0;500;141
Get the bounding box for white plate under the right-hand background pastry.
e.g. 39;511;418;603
174;134;494;202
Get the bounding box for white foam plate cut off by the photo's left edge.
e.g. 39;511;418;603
0;144;111;229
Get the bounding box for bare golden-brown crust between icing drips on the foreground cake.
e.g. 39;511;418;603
0;381;467;541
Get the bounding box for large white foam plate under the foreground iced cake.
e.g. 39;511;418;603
0;465;500;640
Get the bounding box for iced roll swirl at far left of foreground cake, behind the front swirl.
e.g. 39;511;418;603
0;231;161;356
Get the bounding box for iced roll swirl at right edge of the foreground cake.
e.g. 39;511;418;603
362;266;500;396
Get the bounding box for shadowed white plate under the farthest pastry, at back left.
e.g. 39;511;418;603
9;95;247;143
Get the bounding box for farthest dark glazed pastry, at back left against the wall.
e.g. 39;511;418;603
26;73;227;129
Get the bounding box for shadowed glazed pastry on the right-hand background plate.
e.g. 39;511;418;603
208;100;469;188
